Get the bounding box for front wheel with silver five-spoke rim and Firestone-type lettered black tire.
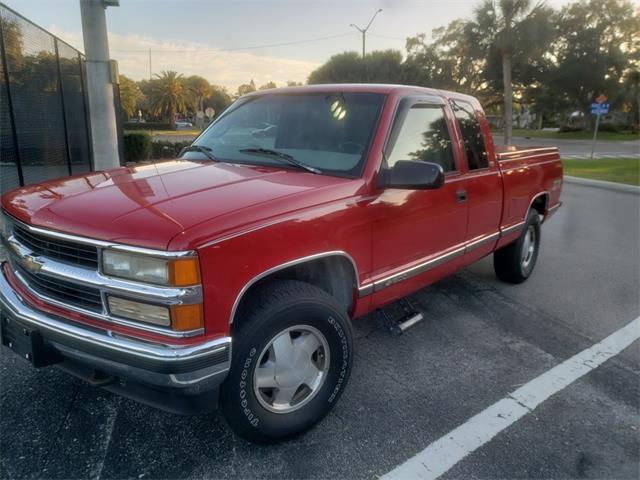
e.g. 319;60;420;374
221;280;353;443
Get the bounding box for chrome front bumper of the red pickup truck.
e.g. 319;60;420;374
0;265;231;404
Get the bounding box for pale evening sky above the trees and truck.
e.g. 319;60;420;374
2;0;567;92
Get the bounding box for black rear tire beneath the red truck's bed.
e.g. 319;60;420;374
493;209;540;284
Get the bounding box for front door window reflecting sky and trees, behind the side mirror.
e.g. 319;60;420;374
386;104;456;173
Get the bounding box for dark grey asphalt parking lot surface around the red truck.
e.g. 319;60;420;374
0;184;640;479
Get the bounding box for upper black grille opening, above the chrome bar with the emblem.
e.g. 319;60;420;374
13;223;98;269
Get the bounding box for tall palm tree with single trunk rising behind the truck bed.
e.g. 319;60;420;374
473;0;550;145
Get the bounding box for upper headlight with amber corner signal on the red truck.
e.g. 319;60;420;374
102;250;200;287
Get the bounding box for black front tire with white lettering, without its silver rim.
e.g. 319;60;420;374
220;280;353;443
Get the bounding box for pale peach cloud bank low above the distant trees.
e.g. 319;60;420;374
49;25;319;92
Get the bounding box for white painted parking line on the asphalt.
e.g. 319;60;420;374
382;317;640;480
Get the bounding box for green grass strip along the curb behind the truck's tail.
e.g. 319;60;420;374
562;158;640;186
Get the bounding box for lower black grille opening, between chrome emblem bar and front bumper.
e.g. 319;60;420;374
16;262;103;313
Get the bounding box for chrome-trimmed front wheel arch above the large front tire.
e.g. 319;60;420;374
229;250;360;325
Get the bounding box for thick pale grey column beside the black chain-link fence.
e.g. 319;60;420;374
80;0;120;170
